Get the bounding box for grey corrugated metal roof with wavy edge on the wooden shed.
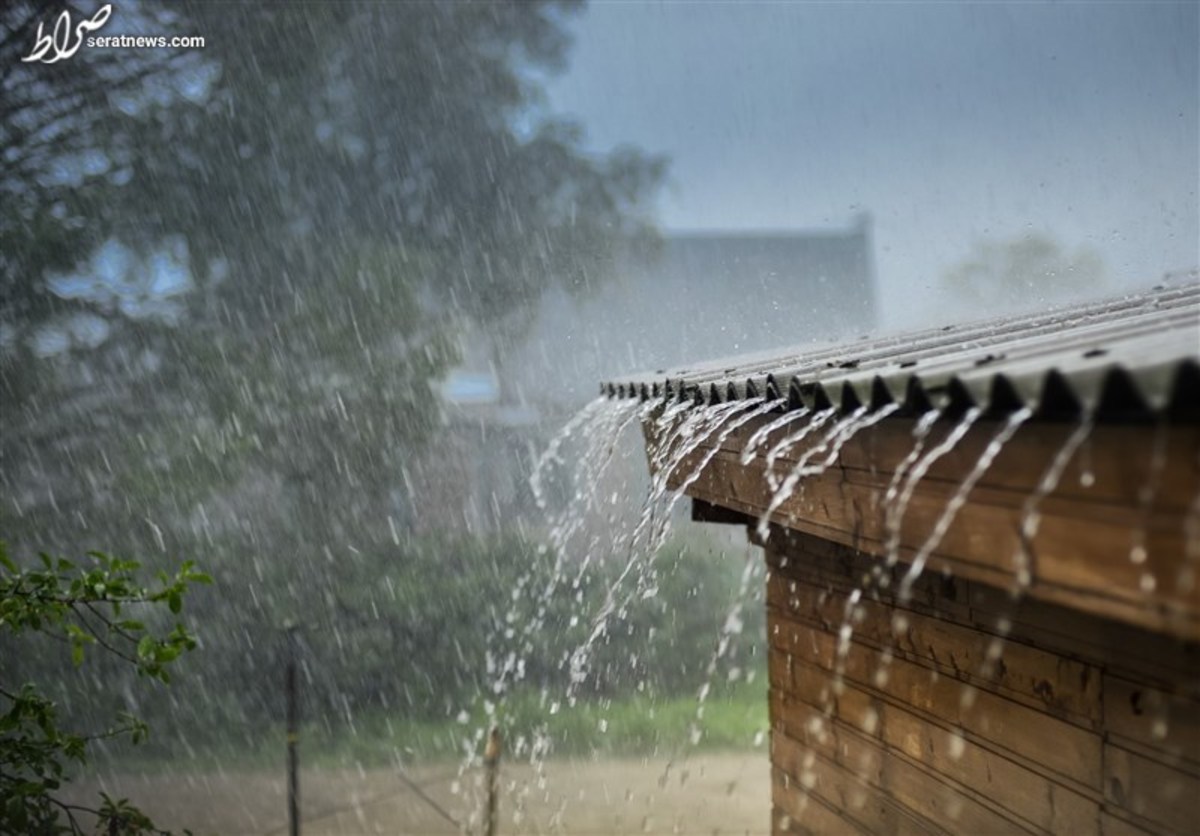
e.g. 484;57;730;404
601;273;1200;417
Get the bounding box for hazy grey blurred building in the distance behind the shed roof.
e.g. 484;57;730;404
505;213;878;405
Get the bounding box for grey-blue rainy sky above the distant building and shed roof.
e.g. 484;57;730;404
548;2;1200;325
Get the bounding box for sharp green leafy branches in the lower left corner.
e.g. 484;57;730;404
0;542;210;834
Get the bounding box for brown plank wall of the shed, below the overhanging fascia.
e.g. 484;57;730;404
767;528;1200;834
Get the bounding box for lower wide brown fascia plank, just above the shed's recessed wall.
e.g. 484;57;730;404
690;453;1200;639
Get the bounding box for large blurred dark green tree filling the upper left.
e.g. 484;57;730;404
0;0;664;743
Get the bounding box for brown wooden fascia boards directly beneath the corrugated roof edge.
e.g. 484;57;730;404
647;419;1200;640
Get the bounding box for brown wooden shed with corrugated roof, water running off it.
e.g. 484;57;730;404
604;283;1200;834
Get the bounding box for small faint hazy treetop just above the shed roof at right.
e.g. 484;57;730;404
942;235;1108;309
